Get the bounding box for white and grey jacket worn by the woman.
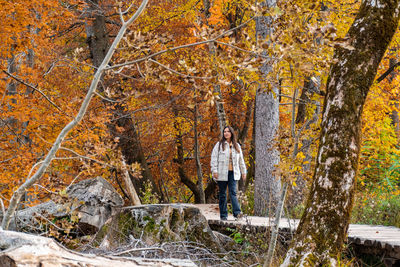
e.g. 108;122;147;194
210;141;247;181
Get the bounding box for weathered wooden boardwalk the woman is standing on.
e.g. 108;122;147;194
195;204;400;266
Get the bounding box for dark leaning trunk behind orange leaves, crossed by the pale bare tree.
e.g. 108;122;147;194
86;0;160;200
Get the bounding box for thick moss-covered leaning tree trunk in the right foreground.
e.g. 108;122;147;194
282;0;400;266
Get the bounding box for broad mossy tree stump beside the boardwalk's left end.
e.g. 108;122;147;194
95;204;225;252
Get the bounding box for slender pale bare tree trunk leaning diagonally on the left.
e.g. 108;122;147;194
1;0;148;229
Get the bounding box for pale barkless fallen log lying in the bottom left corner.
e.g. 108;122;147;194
0;228;196;267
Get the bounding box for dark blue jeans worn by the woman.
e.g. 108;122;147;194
218;171;241;219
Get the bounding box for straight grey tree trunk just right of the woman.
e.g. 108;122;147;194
254;1;281;216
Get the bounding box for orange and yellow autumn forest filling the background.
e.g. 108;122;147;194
0;0;400;241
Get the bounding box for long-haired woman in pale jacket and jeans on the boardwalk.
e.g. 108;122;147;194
210;126;246;220
